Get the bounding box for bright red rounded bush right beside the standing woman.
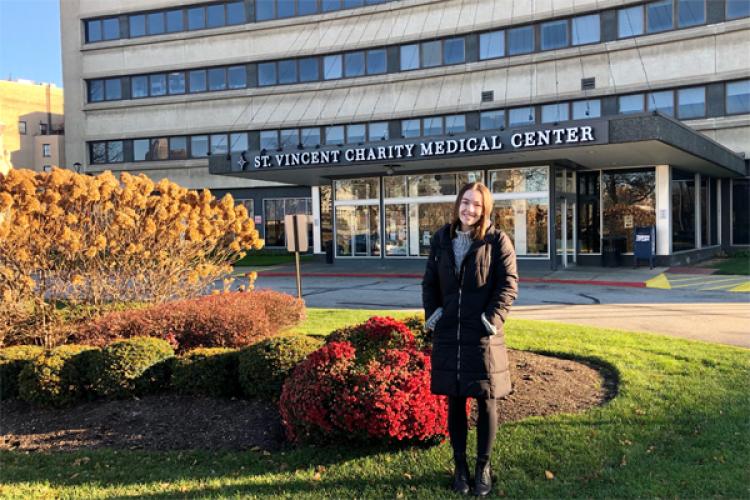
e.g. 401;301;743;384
279;317;447;442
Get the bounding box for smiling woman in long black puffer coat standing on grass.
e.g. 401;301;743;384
422;182;518;496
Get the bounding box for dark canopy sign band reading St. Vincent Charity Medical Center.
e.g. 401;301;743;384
238;125;606;171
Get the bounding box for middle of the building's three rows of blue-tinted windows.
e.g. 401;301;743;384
88;0;750;102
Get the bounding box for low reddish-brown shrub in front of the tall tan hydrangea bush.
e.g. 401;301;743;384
72;290;305;353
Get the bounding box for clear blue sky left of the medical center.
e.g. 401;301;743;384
0;0;62;87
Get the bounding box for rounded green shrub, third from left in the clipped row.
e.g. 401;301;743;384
93;337;174;398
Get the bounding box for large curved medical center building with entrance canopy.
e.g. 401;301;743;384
61;0;750;268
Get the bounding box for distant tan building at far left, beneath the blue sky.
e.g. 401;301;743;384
0;80;65;171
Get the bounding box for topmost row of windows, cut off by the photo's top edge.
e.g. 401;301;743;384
85;0;392;43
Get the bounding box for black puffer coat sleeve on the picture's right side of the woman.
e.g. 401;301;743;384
484;233;518;328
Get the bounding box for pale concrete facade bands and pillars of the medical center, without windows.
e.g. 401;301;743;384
61;0;750;265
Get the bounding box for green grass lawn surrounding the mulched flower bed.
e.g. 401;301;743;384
0;309;750;498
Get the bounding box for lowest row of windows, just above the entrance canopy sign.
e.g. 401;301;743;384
90;80;750;163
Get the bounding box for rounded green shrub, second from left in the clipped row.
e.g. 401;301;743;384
18;344;98;406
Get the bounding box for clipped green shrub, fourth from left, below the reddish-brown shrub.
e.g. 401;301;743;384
172;347;239;397
